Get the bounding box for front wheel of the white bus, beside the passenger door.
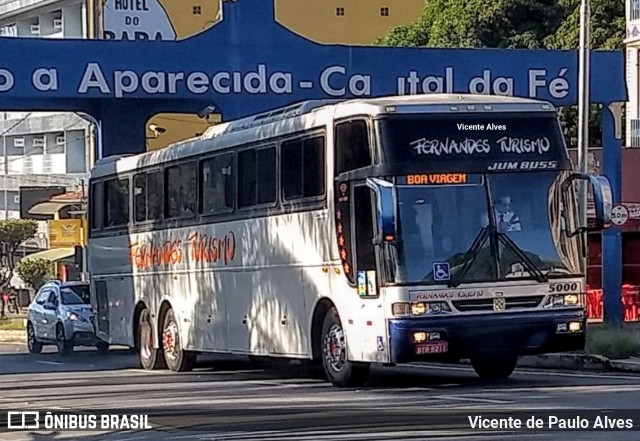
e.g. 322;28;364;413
322;308;369;387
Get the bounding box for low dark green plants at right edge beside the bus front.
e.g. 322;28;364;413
585;326;640;360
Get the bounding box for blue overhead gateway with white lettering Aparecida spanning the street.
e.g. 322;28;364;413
0;0;627;324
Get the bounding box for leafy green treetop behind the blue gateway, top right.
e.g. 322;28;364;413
377;0;625;50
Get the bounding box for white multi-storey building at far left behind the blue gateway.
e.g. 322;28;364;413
0;0;93;253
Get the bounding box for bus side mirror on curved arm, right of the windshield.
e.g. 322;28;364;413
561;173;613;237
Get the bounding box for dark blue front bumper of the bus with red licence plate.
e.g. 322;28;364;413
389;309;587;363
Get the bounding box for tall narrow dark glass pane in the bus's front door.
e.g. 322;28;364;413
353;186;376;270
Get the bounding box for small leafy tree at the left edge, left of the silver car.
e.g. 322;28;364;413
0;219;38;317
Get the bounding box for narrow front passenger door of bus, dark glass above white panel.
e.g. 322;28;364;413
348;184;388;362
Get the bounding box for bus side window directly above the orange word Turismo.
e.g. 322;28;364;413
200;154;235;214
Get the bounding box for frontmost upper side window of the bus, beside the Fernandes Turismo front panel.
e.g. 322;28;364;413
335;120;372;176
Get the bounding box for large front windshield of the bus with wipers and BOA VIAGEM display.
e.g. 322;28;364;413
396;171;580;286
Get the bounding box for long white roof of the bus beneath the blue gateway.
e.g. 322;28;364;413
91;94;555;178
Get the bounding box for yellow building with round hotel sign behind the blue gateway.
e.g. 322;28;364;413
95;0;424;150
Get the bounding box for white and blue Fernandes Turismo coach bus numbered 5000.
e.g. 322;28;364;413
88;95;611;386
